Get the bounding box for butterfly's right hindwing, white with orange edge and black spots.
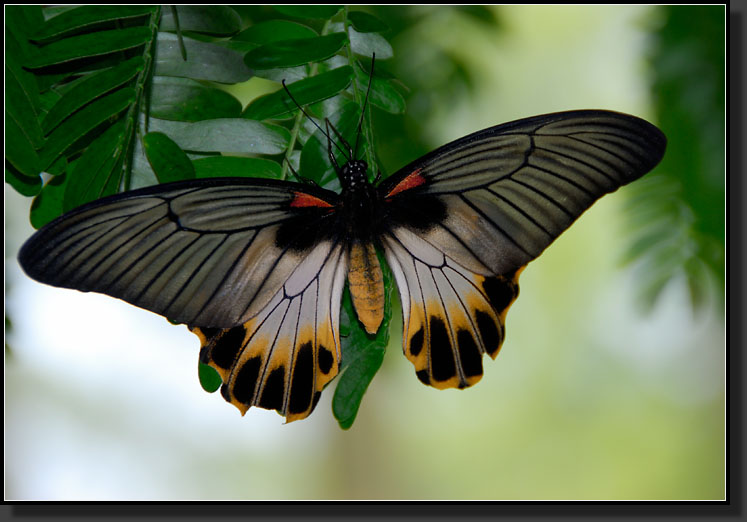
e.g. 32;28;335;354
382;228;519;388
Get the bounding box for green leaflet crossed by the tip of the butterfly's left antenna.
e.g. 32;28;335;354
242;65;353;120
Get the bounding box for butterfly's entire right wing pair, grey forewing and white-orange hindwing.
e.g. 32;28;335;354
379;111;666;388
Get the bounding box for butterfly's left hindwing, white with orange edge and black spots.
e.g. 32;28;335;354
193;242;347;422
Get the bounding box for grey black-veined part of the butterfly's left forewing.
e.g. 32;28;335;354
19;180;336;328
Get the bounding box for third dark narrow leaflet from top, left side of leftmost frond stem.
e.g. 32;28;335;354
42;56;144;134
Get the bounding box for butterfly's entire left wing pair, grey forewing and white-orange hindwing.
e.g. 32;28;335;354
19;179;347;421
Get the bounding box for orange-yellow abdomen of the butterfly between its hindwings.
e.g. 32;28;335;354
348;241;384;334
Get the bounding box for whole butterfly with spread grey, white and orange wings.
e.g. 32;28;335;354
19;99;666;421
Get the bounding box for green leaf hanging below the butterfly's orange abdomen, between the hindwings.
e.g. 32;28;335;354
332;253;392;430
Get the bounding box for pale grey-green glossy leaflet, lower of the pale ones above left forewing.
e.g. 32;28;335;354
150;118;290;154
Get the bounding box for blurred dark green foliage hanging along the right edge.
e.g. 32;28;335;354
627;6;726;311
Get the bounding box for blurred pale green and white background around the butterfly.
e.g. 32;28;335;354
5;6;726;500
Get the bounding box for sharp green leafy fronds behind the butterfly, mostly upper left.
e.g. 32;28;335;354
6;5;405;428
